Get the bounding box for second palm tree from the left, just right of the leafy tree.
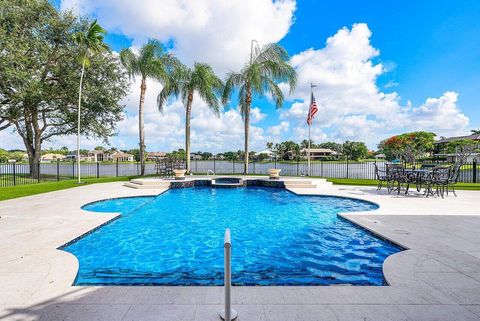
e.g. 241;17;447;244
120;40;177;175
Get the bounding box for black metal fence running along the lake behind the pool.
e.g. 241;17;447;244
0;159;480;187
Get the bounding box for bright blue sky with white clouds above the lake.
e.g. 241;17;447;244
1;0;480;151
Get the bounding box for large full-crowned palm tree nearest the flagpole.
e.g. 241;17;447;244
222;41;297;174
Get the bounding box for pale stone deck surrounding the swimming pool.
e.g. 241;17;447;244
0;180;480;321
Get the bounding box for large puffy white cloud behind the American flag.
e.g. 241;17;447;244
280;24;469;147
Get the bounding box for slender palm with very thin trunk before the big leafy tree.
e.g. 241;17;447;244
73;20;108;183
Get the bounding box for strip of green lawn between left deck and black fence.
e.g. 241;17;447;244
0;177;133;201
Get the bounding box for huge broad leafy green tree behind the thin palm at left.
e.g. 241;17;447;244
0;0;127;176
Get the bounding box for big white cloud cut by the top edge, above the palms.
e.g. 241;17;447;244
61;0;296;73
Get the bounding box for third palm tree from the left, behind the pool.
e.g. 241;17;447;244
157;62;223;172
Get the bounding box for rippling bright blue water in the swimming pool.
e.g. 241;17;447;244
63;187;401;285
